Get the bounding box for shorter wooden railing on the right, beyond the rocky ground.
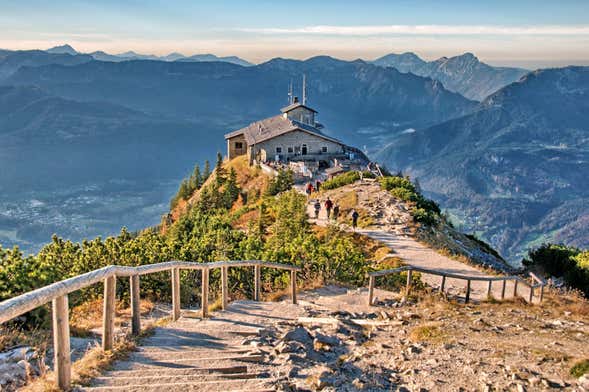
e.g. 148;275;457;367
368;265;546;306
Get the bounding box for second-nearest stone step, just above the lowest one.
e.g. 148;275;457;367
92;372;269;387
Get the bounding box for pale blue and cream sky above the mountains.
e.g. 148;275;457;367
0;0;589;68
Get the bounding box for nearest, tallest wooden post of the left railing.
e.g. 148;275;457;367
52;294;71;391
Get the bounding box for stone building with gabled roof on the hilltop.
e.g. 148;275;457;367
225;97;365;165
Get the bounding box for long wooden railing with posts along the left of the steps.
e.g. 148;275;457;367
0;260;301;390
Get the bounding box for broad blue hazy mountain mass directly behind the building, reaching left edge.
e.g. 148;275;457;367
0;51;476;251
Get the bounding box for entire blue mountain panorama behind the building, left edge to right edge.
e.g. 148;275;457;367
0;46;589;260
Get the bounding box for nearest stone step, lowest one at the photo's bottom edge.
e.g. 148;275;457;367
79;379;276;392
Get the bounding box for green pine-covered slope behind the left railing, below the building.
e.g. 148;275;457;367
0;159;376;325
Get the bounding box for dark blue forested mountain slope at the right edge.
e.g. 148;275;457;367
378;67;589;259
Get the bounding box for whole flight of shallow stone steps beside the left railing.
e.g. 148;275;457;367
78;301;300;392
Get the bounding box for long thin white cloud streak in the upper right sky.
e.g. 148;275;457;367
238;25;589;36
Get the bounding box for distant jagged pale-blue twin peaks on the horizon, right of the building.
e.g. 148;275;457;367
373;52;529;101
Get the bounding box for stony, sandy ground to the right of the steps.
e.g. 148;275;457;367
244;287;589;391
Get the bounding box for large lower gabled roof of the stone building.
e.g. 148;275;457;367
225;114;344;146
